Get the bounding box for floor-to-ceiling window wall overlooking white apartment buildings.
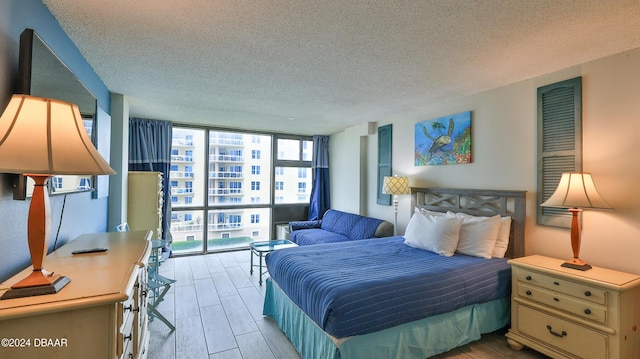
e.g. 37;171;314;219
170;126;312;254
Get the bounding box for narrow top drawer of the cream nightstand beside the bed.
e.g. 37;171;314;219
516;268;607;305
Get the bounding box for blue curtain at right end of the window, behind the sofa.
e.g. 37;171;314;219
309;136;331;221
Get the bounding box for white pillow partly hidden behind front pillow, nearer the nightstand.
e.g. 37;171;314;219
448;212;500;259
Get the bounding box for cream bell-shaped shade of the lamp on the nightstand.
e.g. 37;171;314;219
541;172;611;209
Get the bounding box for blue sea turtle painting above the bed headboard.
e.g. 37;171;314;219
414;111;473;166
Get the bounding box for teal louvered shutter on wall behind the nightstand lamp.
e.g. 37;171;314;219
537;77;582;228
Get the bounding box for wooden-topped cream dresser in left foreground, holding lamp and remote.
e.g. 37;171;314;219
0;231;151;359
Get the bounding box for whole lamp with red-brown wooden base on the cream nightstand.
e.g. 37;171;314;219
541;172;611;270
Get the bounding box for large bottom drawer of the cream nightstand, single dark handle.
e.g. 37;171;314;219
513;304;609;359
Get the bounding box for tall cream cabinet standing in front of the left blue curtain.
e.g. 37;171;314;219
127;171;163;239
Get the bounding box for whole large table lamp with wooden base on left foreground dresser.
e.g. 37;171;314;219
0;95;115;299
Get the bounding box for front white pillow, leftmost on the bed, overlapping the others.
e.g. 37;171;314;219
404;208;463;257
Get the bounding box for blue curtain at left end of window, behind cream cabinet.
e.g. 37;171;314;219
129;118;172;243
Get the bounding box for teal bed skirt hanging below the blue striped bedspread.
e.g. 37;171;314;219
263;278;511;359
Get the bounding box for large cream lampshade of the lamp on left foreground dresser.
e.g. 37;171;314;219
0;95;115;175
